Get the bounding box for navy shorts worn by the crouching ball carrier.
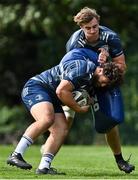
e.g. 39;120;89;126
21;79;63;113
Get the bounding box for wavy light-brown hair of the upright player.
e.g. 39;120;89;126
74;7;100;26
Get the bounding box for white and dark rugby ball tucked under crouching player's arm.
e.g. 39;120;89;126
72;89;91;106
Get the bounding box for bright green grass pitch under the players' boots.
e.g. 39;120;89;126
0;145;138;179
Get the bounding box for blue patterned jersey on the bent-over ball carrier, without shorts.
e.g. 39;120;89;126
31;48;98;93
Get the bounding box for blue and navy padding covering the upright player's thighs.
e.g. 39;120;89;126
92;87;124;133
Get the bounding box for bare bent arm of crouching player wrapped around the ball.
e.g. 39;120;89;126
56;80;89;112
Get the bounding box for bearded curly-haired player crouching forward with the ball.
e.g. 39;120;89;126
7;48;122;174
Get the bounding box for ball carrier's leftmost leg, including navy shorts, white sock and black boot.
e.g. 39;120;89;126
7;80;55;169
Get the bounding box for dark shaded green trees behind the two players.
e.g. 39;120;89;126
0;0;138;145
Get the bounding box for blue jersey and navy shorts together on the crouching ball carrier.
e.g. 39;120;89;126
21;48;98;113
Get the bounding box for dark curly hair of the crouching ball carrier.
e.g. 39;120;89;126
101;62;123;87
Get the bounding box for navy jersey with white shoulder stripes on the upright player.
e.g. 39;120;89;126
66;26;123;58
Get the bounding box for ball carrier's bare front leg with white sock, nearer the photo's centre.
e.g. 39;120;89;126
36;113;69;174
